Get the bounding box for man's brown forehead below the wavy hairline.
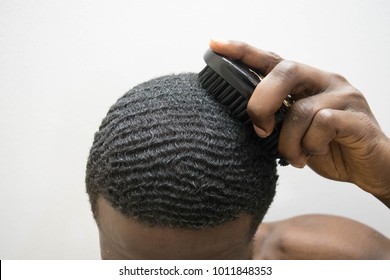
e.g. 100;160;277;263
97;198;252;260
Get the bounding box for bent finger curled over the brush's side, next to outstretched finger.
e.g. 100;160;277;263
247;60;329;137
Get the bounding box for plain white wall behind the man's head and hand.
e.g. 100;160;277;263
0;0;390;259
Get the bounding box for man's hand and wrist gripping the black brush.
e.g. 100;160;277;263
210;41;390;208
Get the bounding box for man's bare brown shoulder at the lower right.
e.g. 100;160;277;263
254;215;390;259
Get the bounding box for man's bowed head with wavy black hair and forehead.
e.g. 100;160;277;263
86;74;277;259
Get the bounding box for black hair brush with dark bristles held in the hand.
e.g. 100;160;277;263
198;49;292;165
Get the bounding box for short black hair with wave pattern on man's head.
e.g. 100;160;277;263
86;73;277;238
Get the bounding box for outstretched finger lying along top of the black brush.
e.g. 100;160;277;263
210;40;283;76
